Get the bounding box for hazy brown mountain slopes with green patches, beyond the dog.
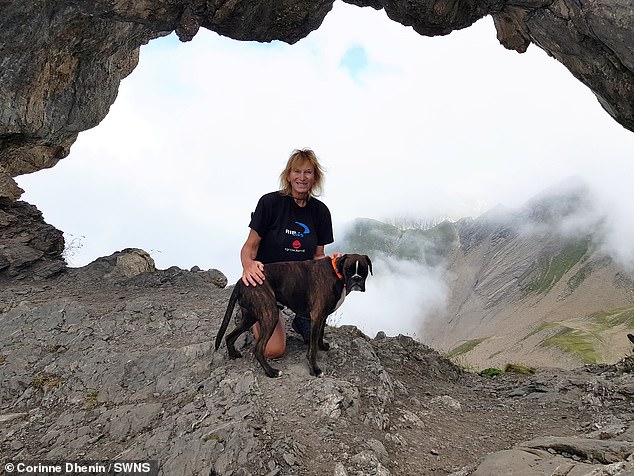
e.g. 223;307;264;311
344;180;634;369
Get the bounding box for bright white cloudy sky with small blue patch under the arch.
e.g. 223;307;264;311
18;2;634;338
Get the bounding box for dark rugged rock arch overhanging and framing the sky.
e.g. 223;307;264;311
0;0;634;200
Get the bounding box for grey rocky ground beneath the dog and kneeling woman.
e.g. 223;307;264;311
0;251;634;476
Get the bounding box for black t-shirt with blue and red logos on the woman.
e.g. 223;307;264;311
249;192;334;263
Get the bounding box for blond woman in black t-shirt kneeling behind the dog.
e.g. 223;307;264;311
240;149;334;358
